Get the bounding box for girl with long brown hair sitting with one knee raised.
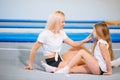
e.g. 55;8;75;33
55;23;114;75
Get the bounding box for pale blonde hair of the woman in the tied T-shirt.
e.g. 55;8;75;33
46;11;65;33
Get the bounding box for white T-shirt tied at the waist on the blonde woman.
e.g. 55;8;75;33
37;30;68;56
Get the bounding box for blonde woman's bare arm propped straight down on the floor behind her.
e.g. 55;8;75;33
24;41;42;70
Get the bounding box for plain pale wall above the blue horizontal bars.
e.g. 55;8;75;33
0;0;120;20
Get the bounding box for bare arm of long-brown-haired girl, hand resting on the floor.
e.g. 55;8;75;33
99;43;112;75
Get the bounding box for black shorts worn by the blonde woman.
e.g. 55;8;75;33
46;55;62;67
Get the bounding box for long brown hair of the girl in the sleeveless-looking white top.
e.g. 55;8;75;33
92;23;114;60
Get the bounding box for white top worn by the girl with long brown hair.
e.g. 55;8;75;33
94;39;109;72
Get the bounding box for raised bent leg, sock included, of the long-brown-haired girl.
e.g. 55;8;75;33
56;50;100;74
